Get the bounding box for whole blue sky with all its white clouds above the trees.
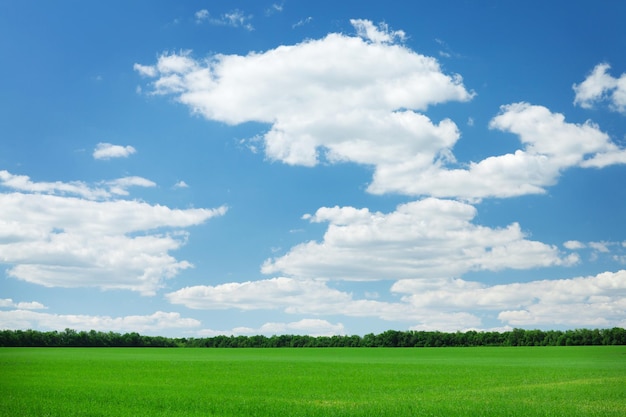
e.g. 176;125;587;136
0;0;626;337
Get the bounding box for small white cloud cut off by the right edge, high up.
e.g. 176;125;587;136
573;63;626;113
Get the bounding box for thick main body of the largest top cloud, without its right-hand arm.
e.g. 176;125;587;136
134;21;473;171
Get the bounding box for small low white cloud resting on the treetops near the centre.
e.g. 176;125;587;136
197;319;346;337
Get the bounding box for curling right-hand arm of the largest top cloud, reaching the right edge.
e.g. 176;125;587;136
369;103;626;200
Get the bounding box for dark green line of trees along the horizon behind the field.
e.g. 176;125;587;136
0;327;626;348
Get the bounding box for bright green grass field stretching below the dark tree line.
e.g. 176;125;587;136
0;346;626;417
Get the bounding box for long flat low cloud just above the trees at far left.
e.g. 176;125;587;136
0;310;200;335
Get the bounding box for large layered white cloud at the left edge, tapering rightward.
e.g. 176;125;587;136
0;174;226;295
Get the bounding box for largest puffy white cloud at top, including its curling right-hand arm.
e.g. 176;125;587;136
135;20;626;200
